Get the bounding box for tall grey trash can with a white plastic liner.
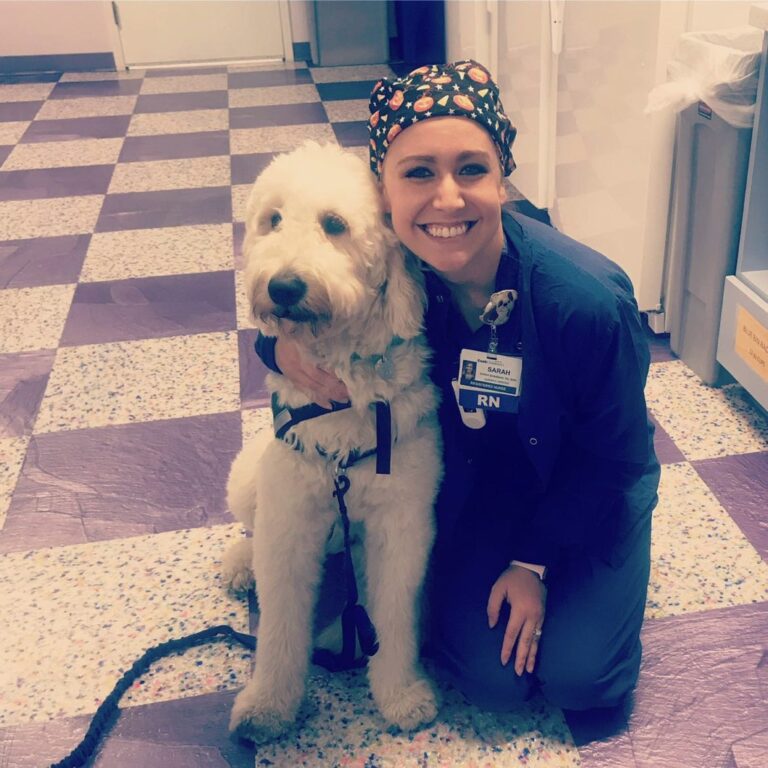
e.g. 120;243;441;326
648;27;762;386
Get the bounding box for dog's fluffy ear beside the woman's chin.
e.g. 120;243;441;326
384;244;425;339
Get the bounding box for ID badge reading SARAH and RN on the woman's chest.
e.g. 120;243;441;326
459;349;523;413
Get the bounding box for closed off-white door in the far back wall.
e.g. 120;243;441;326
115;0;293;67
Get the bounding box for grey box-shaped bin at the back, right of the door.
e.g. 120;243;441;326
315;0;389;67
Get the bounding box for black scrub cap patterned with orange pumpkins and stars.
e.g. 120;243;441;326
368;59;517;177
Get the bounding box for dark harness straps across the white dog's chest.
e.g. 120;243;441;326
272;392;392;475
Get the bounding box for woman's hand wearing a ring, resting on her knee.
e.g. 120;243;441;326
488;565;547;675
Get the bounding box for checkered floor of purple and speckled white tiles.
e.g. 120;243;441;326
0;65;768;768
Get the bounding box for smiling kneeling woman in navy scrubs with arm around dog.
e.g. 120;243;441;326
257;61;659;710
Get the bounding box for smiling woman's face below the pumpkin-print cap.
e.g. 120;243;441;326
382;117;505;284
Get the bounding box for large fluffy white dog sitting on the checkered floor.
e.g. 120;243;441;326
224;143;441;743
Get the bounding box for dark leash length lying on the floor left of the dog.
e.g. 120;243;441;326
51;624;256;768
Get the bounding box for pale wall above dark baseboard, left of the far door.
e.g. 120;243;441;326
0;0;114;56
